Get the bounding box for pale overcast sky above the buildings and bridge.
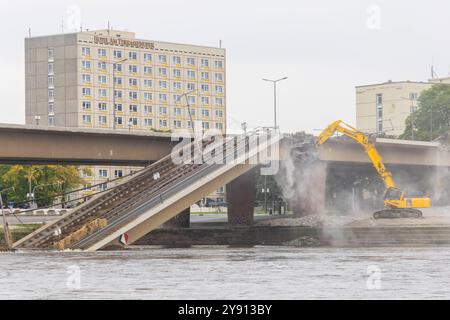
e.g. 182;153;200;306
0;0;450;132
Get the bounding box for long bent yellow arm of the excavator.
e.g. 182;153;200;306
316;120;395;189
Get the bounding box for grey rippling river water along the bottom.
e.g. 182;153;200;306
0;247;450;299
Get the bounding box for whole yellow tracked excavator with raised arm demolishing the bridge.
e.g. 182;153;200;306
316;120;431;219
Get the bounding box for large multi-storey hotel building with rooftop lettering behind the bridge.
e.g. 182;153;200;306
25;30;226;202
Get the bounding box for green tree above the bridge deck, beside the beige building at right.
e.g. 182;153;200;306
400;84;450;141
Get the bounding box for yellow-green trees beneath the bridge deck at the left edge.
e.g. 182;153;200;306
0;165;87;206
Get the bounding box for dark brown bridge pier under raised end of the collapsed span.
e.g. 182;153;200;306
226;169;257;225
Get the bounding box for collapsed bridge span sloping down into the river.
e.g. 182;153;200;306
14;132;280;251
